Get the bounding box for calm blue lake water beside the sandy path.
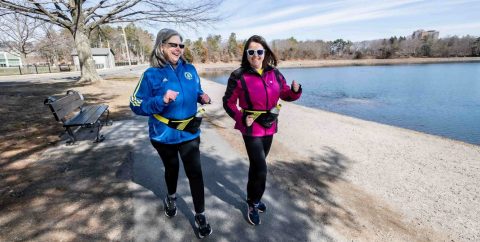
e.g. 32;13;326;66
205;63;480;144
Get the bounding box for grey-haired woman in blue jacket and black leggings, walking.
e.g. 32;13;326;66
130;29;212;238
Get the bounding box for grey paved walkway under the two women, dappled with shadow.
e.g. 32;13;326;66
39;112;344;241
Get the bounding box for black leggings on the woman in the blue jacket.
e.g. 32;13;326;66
151;137;205;213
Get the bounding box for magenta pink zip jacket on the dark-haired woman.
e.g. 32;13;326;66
223;66;302;137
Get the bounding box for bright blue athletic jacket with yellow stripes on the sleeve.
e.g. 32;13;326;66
130;59;203;144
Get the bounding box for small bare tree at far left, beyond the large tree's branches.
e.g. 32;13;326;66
0;12;43;64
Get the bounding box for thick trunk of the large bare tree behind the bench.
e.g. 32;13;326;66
75;26;102;82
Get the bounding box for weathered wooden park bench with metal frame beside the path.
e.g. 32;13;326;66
44;90;111;145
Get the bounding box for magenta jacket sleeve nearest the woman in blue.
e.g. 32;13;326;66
222;73;242;122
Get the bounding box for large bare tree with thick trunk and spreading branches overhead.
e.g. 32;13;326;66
0;0;222;82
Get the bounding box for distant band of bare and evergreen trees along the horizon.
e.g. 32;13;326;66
4;23;480;64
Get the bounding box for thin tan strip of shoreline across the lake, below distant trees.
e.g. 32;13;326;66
193;57;480;73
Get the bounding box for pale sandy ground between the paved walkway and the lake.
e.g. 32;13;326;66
202;76;480;241
